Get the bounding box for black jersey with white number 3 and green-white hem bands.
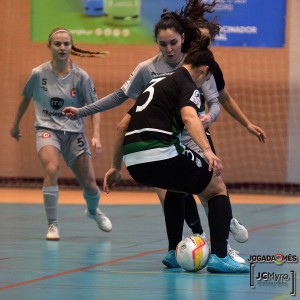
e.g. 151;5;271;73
123;67;201;167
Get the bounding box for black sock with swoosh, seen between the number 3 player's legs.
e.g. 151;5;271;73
184;194;203;234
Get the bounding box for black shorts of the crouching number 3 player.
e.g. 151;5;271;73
127;148;212;194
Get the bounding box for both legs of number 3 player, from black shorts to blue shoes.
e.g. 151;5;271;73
127;149;249;273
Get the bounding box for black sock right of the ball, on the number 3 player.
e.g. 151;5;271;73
208;195;232;258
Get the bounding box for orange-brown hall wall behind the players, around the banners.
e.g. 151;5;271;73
0;0;300;193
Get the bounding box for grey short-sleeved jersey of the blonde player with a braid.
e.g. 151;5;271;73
22;61;97;132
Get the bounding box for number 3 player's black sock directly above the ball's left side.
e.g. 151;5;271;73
164;191;185;251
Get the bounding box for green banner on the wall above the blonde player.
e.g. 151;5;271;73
31;0;156;45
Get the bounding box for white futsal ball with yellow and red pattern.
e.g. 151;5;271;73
176;235;210;272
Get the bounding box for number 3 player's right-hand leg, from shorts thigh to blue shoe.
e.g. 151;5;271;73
171;148;249;273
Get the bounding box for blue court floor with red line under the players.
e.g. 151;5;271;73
0;193;300;300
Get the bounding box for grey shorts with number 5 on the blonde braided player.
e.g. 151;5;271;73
36;128;91;167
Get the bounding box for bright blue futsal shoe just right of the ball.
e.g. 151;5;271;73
207;254;250;273
